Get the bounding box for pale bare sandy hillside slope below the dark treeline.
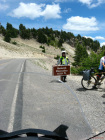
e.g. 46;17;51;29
0;36;75;70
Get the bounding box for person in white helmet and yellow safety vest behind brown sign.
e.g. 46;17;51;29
57;51;70;82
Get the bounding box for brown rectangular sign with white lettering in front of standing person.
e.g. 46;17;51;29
52;65;70;76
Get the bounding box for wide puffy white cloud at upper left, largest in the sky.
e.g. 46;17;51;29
9;2;61;19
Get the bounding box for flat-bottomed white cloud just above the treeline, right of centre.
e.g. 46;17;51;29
63;16;99;32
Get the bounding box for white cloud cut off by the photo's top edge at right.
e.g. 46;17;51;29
78;0;105;8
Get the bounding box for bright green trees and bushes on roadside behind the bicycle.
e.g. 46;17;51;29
71;44;105;75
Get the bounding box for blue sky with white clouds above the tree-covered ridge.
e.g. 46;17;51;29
0;0;105;46
